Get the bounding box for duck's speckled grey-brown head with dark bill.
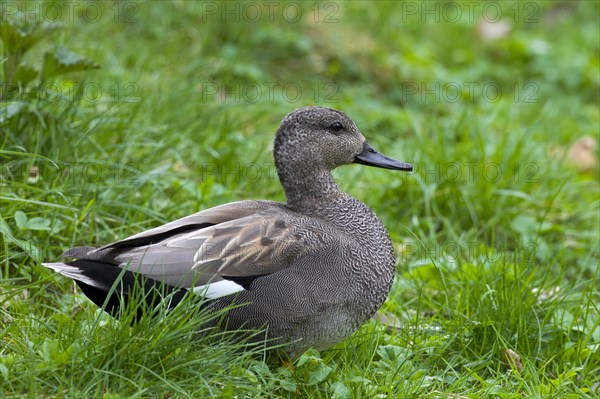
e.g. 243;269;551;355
273;107;412;177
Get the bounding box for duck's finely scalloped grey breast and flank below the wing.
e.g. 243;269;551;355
211;194;395;354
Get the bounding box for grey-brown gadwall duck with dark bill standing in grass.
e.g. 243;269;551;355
44;107;412;355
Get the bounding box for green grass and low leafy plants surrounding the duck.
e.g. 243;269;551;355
0;1;600;398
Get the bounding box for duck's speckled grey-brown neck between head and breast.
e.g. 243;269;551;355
279;168;346;209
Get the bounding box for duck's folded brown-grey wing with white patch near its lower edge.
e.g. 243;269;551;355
52;201;335;297
